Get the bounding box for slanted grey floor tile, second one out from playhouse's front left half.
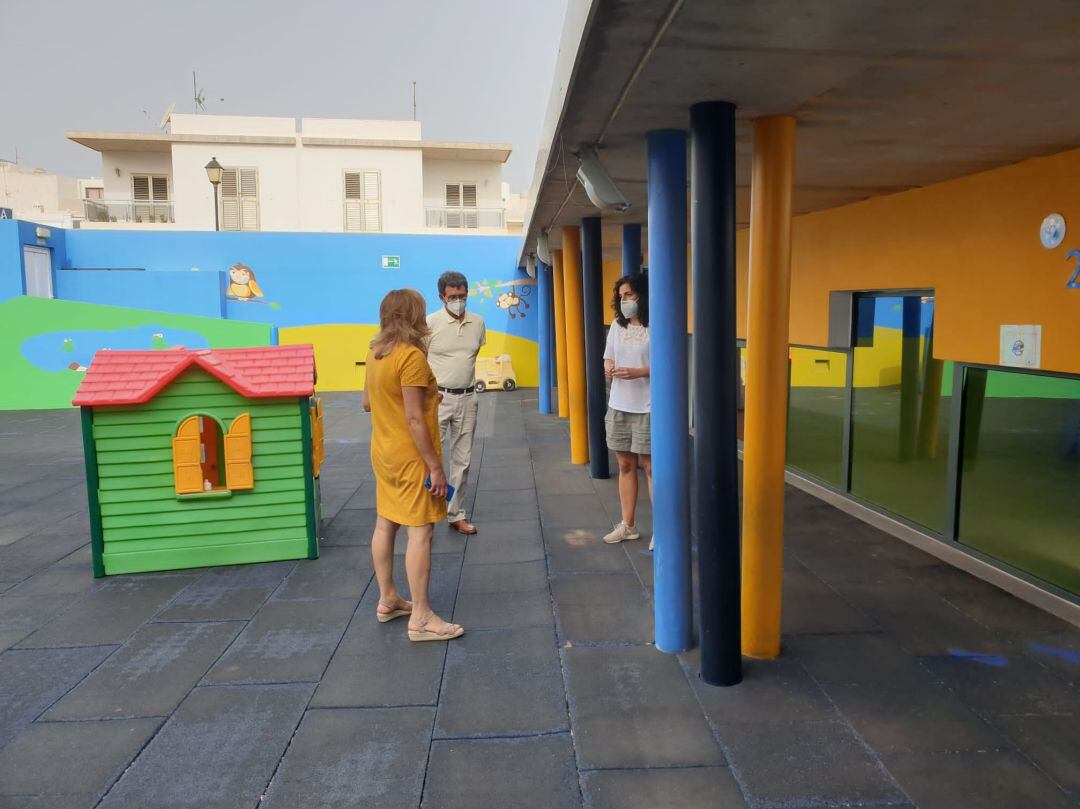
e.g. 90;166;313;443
45;622;243;719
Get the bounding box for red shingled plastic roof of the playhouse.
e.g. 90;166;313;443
71;346;315;405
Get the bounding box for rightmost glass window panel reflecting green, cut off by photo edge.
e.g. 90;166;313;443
959;368;1080;594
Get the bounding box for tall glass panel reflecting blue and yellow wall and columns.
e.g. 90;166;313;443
851;295;950;531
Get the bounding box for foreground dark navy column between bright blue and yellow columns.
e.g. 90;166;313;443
690;102;742;686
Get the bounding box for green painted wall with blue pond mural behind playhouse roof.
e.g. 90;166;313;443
0;297;271;410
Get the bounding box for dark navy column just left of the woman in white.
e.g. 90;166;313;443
581;216;610;480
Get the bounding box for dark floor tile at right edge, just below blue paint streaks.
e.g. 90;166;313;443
922;650;1080;716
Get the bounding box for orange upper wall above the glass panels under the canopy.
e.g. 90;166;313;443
738;150;1080;373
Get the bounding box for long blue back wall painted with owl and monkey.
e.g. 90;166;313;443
63;230;538;340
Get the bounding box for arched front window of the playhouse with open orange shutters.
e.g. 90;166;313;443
173;413;255;495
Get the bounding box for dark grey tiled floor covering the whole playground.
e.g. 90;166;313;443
0;392;1080;809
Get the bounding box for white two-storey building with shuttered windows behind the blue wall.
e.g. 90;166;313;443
68;114;522;234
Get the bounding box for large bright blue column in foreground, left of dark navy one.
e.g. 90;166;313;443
647;130;691;651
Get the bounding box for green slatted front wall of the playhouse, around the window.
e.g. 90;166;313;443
93;368;309;575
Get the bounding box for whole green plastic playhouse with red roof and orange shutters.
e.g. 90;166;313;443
73;346;324;577
